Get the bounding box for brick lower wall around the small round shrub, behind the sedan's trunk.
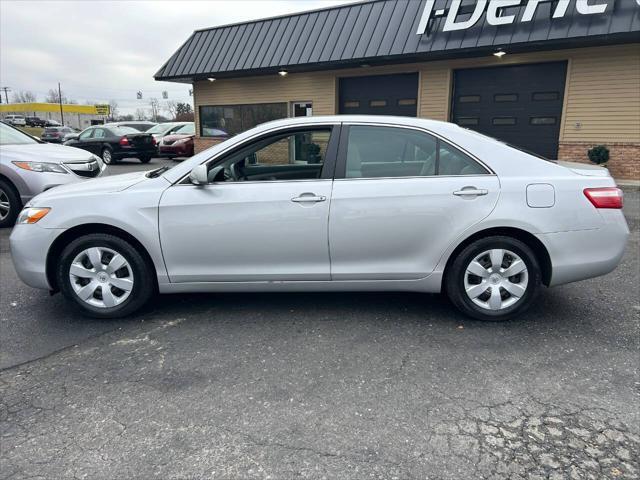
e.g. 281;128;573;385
558;142;640;180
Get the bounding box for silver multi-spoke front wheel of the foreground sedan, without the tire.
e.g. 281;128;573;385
69;247;134;308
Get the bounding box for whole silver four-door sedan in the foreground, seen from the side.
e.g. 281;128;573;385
11;116;629;320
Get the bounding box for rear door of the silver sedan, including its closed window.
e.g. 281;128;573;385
329;124;499;280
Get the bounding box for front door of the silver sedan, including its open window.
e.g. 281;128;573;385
160;126;338;283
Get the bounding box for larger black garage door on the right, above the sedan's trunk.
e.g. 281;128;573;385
453;62;567;158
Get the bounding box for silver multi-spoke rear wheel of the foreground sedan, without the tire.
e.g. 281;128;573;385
464;248;529;310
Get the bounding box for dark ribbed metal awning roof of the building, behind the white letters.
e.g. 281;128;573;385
155;0;640;82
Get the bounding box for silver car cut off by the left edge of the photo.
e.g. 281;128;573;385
0;122;105;228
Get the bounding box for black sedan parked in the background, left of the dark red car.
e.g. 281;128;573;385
64;125;157;164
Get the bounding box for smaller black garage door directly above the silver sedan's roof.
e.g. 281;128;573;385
339;73;418;117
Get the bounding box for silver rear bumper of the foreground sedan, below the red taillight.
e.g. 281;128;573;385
536;210;629;286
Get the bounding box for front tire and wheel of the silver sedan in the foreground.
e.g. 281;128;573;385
56;233;156;319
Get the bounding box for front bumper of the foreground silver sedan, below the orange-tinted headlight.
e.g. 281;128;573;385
9;223;64;290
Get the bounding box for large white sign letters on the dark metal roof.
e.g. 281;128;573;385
416;0;608;35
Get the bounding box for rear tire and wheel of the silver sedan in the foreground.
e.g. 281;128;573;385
444;236;542;322
